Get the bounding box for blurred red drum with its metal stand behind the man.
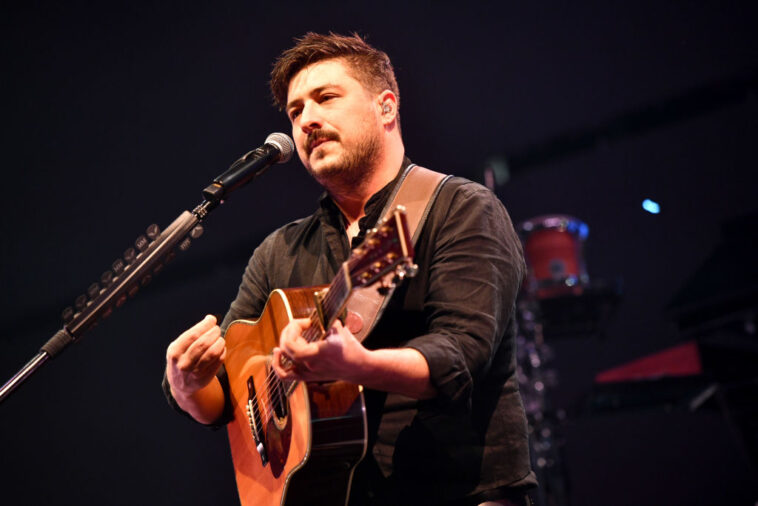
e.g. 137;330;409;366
516;215;620;505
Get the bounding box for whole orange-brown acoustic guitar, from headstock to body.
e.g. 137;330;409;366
224;207;415;506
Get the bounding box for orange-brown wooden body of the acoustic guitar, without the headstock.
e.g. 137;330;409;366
224;288;367;506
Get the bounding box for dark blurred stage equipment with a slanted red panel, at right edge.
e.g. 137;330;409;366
578;212;758;474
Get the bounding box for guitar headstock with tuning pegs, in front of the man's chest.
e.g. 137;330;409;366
347;206;416;287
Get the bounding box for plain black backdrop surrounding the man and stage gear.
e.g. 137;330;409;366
0;0;758;505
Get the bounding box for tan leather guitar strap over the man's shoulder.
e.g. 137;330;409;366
347;164;450;341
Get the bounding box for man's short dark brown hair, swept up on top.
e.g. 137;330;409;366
271;32;400;109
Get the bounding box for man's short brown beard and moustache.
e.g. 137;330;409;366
308;130;381;191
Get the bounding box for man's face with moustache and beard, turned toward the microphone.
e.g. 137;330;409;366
286;59;383;184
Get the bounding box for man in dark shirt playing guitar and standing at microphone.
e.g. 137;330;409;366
164;33;536;505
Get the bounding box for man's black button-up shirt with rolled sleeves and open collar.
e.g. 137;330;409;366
168;160;536;504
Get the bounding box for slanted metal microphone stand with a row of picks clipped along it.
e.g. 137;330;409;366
0;150;278;403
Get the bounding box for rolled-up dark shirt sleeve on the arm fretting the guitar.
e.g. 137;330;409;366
406;183;526;405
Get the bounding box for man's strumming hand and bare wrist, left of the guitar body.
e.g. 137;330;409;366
166;315;226;423
